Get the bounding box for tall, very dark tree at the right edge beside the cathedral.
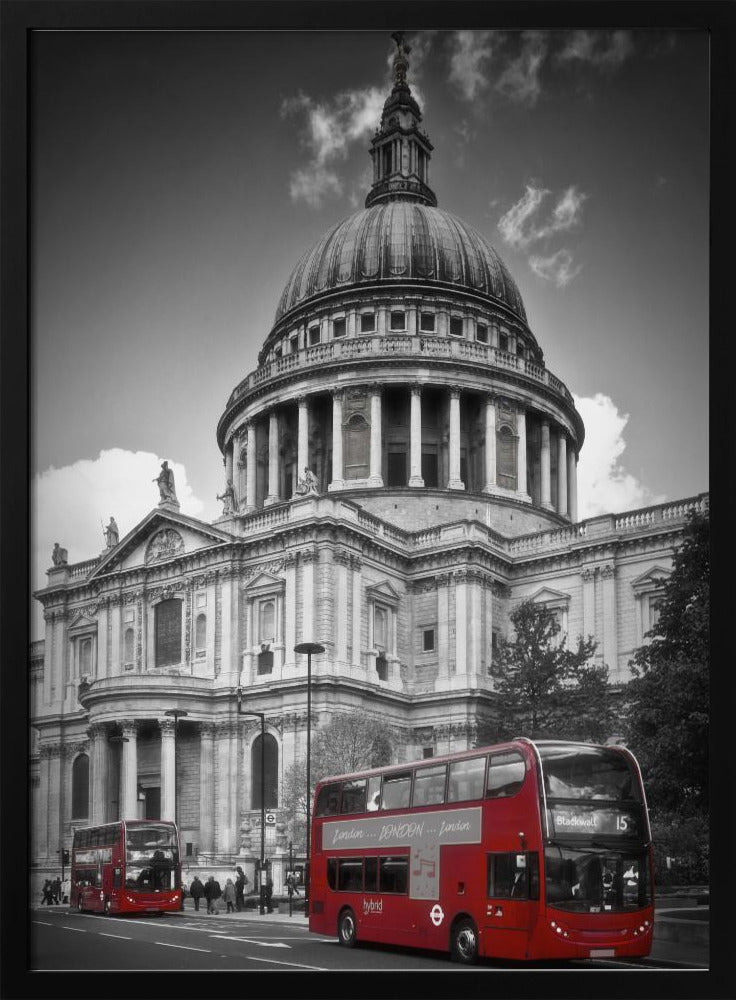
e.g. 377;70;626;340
626;512;710;817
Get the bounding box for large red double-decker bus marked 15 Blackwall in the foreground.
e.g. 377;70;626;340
309;738;654;963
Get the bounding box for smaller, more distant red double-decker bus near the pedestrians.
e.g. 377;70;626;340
69;819;181;915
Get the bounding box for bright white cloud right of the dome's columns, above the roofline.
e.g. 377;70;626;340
574;392;667;520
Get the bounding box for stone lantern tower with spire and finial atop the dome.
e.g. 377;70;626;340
365;31;437;208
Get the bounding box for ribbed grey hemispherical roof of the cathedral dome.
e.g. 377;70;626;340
275;196;526;325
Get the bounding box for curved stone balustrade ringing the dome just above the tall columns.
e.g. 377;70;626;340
227;333;573;407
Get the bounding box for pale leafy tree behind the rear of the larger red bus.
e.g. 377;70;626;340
282;712;393;848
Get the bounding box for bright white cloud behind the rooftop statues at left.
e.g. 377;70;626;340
31;448;204;637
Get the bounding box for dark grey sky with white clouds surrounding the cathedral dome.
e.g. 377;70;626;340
31;29;709;638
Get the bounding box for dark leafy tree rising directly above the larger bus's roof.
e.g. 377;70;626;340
490;600;613;741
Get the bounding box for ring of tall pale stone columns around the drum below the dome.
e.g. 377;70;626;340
225;384;577;521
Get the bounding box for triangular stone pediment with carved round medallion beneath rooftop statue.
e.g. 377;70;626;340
91;509;232;578
